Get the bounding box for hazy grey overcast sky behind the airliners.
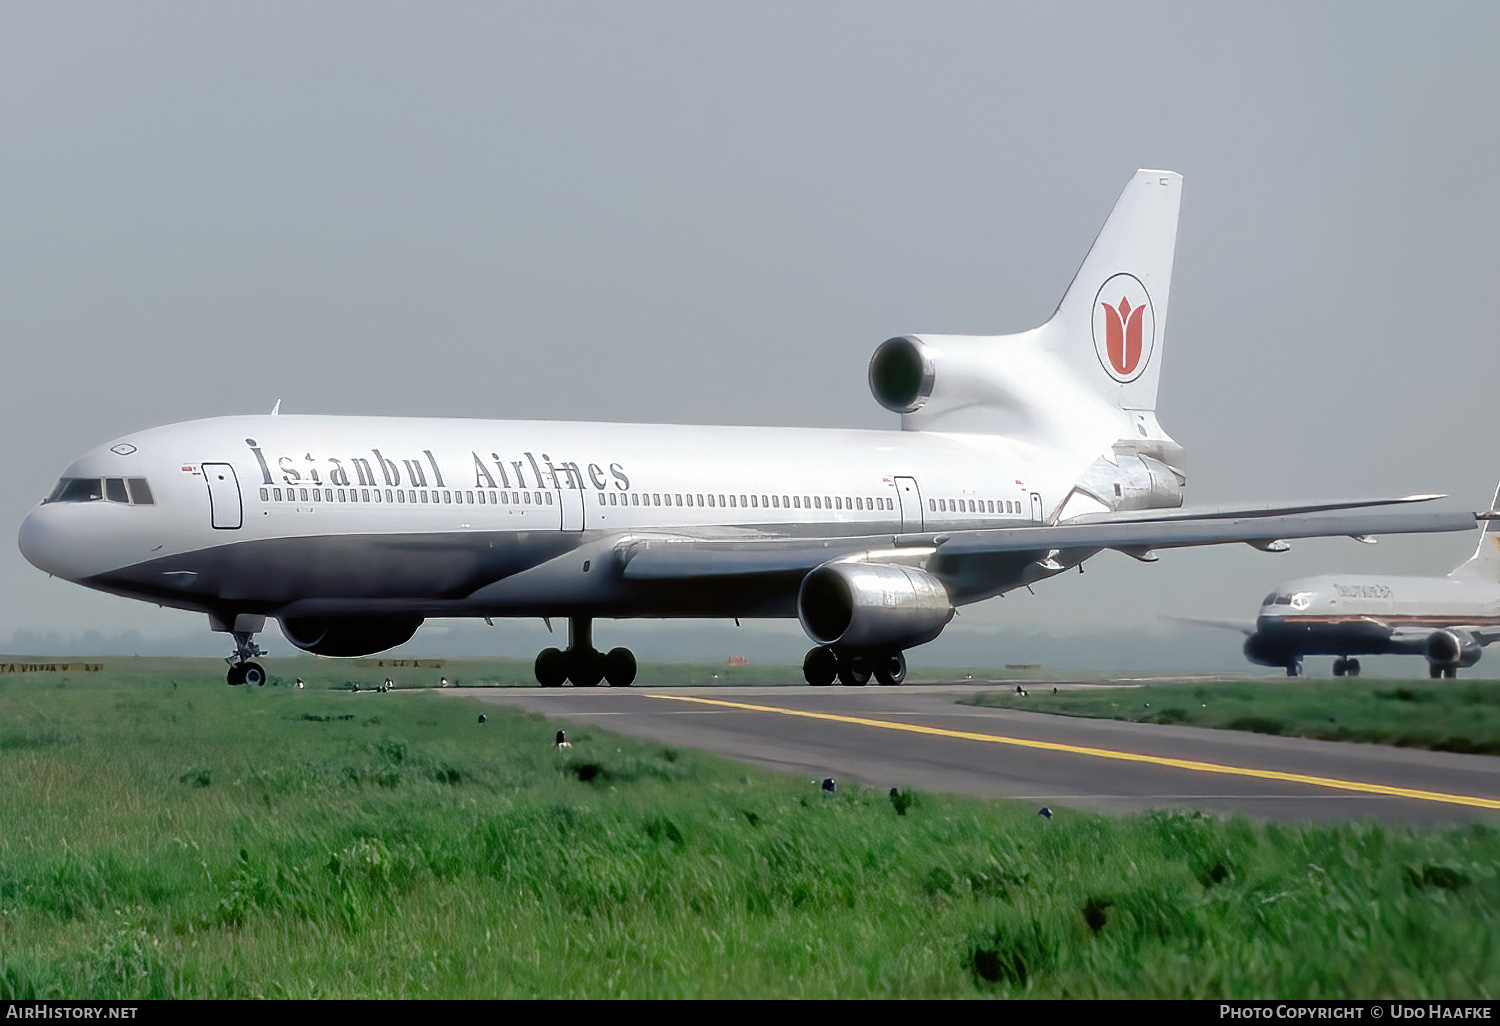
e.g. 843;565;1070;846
0;0;1500;659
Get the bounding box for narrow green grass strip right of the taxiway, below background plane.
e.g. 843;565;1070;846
966;680;1500;755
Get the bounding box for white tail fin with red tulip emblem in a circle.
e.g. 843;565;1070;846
1041;170;1182;410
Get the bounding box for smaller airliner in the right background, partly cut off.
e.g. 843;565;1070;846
1215;489;1500;680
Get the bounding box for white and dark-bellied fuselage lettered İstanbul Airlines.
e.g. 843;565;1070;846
21;416;1091;617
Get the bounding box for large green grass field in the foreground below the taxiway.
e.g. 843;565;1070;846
0;659;1500;998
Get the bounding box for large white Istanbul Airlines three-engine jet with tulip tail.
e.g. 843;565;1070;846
20;170;1475;687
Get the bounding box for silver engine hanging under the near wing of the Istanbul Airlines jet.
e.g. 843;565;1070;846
797;563;953;648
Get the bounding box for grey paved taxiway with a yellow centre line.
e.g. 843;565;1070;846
450;684;1500;825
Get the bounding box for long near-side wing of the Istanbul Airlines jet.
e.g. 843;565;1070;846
621;510;1475;581
